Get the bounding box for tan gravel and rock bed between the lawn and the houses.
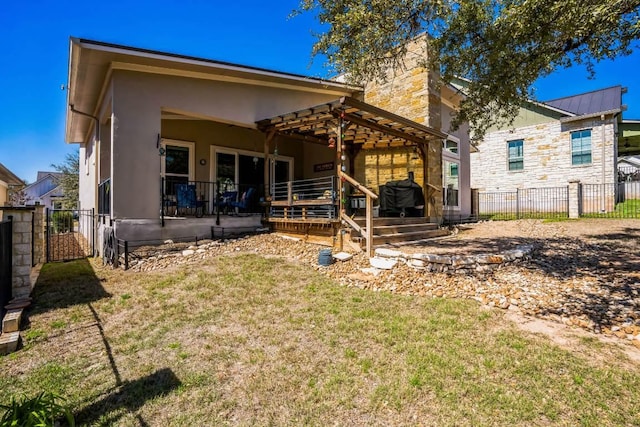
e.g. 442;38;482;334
124;220;640;348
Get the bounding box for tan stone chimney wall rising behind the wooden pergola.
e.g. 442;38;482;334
362;38;442;220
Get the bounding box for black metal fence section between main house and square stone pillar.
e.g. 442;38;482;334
478;187;569;219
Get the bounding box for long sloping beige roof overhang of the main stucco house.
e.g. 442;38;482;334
65;37;362;143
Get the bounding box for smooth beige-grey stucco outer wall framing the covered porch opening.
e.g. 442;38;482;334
111;71;350;218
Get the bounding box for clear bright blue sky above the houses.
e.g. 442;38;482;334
0;0;640;182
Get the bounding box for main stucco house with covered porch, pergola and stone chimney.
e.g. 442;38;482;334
65;38;468;258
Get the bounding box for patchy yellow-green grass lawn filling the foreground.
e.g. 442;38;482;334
0;255;640;426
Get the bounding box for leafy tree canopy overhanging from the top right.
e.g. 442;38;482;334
298;0;640;139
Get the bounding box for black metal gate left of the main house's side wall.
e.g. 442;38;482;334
45;209;95;262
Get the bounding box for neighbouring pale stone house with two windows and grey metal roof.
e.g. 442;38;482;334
471;86;624;191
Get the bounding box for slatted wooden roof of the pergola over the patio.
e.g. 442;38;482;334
256;97;447;149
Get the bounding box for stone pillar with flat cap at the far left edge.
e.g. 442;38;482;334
2;206;36;298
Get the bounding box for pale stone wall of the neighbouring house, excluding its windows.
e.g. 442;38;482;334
471;119;616;191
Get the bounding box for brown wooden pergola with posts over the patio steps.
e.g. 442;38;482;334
256;97;447;256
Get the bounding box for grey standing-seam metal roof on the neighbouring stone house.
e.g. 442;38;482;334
544;86;622;116
